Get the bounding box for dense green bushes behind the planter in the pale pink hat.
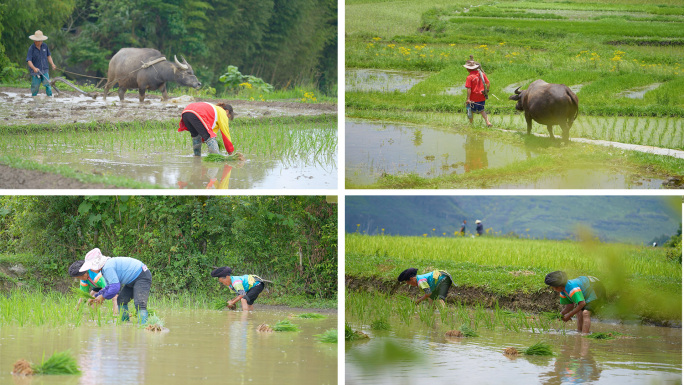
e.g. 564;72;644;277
0;196;337;299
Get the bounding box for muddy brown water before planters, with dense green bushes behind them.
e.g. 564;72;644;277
0;305;337;385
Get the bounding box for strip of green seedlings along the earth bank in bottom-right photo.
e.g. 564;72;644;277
345;291;566;334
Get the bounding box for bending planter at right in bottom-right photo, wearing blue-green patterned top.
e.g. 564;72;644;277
544;271;606;333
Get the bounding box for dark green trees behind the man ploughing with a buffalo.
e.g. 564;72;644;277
0;0;337;92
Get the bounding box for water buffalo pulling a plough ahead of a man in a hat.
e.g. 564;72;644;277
104;48;202;102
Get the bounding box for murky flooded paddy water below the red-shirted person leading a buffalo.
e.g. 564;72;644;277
345;117;665;189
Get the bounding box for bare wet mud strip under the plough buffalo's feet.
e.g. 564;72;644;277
0;87;337;125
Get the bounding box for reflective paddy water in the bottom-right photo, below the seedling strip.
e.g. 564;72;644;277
345;319;682;385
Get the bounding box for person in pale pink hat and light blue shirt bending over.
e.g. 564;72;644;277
79;249;152;324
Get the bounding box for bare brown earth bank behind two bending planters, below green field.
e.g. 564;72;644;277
344;275;682;327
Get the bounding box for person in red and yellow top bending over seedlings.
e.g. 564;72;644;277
178;102;235;156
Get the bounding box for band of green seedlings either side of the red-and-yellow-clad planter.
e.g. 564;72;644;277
0;115;337;164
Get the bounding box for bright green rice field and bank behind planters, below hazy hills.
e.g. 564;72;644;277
345;234;682;322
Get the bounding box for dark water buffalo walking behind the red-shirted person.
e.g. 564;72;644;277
508;79;579;141
